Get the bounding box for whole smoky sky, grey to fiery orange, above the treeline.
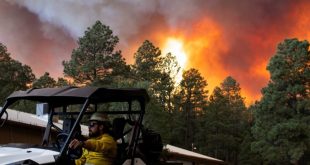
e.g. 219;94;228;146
0;0;310;102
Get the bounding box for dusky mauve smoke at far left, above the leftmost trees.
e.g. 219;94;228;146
0;1;75;77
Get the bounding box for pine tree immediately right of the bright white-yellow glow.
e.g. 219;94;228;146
175;68;208;150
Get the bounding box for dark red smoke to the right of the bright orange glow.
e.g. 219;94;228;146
201;0;300;96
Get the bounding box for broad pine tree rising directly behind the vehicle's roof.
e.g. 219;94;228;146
63;21;130;86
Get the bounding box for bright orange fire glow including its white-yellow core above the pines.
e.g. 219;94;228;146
155;18;228;98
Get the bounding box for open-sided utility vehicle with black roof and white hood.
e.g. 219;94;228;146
0;86;163;165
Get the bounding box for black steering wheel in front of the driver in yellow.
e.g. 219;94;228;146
56;133;83;159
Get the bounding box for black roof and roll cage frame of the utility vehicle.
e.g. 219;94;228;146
0;86;149;163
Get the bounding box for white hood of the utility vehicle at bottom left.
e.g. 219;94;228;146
0;146;59;164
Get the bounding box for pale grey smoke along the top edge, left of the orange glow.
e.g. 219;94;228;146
9;0;158;40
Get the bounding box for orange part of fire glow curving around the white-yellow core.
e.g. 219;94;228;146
157;18;227;98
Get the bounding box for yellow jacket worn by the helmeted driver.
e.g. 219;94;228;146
75;134;117;165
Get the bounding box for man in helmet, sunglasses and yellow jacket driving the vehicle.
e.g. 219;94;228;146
69;112;117;165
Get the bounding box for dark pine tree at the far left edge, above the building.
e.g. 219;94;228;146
0;43;35;103
